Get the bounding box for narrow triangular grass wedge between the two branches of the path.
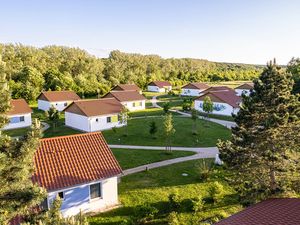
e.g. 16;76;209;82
112;149;195;170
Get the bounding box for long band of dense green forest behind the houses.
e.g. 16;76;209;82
0;44;278;101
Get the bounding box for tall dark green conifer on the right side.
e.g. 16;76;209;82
218;62;300;202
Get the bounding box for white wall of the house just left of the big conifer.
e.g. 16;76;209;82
195;100;239;116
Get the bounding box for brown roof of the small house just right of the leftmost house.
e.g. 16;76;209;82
38;91;80;102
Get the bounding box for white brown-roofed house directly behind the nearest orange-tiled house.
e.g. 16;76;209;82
65;98;126;132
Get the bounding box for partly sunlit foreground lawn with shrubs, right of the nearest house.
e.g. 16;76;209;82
89;160;241;225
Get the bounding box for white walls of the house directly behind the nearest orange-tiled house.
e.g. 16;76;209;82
65;112;125;132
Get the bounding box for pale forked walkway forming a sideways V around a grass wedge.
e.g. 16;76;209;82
109;145;219;176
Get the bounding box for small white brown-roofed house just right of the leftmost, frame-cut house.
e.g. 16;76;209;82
38;91;80;111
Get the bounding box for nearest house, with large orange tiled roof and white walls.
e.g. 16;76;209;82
32;132;122;217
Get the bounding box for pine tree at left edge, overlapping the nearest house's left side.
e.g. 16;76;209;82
0;76;45;224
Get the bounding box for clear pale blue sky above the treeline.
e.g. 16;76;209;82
0;0;300;64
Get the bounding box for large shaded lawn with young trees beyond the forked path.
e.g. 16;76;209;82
103;117;231;147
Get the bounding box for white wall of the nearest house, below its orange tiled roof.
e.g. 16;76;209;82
48;175;118;217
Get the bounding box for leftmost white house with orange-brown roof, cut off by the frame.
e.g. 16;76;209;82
3;99;32;130
